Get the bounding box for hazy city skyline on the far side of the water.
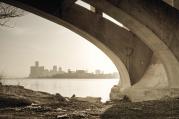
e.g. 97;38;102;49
27;61;118;79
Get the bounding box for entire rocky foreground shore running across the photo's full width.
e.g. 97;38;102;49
0;85;179;119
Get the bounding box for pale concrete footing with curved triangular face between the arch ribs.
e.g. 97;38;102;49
110;58;170;102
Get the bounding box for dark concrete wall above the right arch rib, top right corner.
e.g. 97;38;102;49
107;0;179;59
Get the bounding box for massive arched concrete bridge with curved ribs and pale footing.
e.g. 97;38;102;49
1;0;179;101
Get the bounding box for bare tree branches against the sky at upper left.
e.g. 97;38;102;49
0;2;24;26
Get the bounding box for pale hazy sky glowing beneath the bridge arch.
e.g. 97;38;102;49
0;13;117;77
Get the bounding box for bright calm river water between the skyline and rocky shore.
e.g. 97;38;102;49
2;79;119;102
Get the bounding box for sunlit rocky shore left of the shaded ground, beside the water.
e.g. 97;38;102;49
0;85;105;119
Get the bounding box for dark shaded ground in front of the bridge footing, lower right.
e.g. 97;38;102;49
101;97;179;119
